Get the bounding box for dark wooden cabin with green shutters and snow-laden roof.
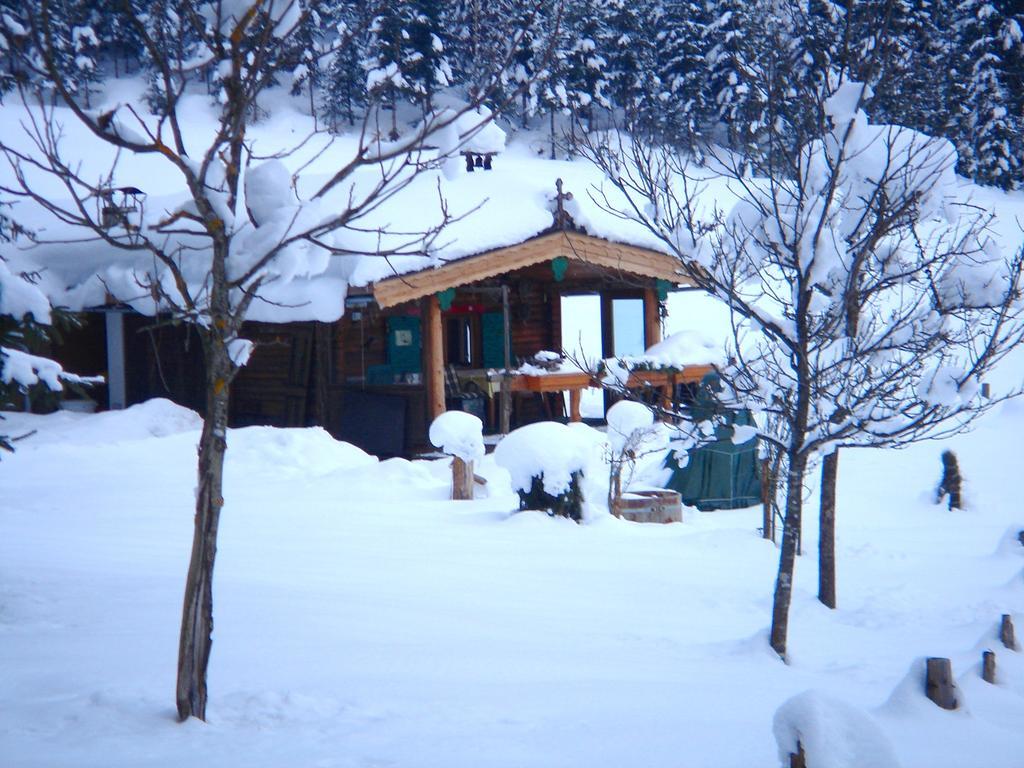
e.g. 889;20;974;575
34;122;720;455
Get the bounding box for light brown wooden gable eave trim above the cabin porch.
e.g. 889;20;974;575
374;231;693;307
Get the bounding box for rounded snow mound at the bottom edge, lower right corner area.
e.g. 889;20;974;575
772;690;899;768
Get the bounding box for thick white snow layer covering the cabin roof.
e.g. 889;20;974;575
0;81;688;322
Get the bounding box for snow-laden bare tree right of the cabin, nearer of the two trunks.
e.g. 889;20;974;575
582;80;1024;657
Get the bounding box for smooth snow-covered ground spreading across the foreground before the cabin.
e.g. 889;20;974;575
0;391;1024;768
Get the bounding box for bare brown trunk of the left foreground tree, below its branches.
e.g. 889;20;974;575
176;332;231;721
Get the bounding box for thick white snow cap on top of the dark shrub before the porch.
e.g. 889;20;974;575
495;421;603;496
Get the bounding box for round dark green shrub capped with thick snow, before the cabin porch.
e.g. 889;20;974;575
495;421;592;521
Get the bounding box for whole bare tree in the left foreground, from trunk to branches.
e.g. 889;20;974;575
0;0;544;720
